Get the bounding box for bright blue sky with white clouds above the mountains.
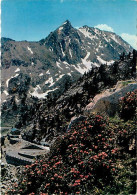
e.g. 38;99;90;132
1;0;137;48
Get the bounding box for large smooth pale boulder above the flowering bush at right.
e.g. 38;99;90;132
85;81;137;117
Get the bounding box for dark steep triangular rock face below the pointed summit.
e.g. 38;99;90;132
40;20;86;65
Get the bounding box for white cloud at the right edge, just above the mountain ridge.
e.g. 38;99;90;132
121;33;137;49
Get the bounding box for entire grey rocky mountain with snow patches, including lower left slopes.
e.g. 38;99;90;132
1;20;132;102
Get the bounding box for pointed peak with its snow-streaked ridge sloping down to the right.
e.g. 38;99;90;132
40;21;131;66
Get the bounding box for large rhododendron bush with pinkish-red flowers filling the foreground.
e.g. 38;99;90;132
9;110;136;195
